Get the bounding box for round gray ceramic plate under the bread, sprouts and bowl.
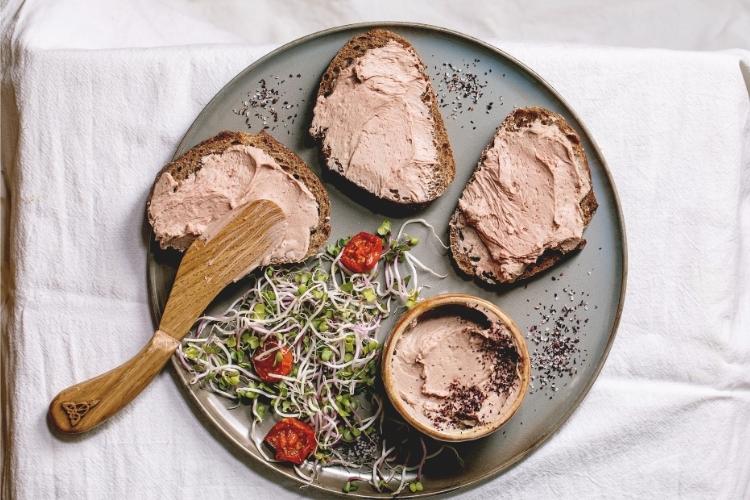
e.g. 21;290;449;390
148;24;626;496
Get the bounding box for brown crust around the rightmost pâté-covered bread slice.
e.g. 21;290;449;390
448;106;598;286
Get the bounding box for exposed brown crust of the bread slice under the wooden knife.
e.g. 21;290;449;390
146;131;331;264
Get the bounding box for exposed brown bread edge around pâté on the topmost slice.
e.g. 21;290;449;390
311;29;456;209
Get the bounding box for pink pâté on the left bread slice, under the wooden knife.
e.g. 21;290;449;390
148;144;319;264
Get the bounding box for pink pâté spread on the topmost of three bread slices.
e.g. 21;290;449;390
310;32;454;204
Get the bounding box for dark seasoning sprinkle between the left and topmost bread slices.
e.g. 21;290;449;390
232;73;305;134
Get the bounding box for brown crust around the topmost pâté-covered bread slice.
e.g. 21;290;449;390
313;28;456;210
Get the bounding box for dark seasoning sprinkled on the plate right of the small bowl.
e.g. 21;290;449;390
526;271;597;399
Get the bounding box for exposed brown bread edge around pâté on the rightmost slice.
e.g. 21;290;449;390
449;107;598;286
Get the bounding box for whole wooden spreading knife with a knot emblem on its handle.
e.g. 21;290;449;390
49;200;286;434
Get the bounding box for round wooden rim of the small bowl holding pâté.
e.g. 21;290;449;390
381;293;531;442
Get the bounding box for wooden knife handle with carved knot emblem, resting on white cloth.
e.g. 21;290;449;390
49;330;180;434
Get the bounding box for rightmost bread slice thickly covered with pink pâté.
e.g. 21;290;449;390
451;108;596;283
